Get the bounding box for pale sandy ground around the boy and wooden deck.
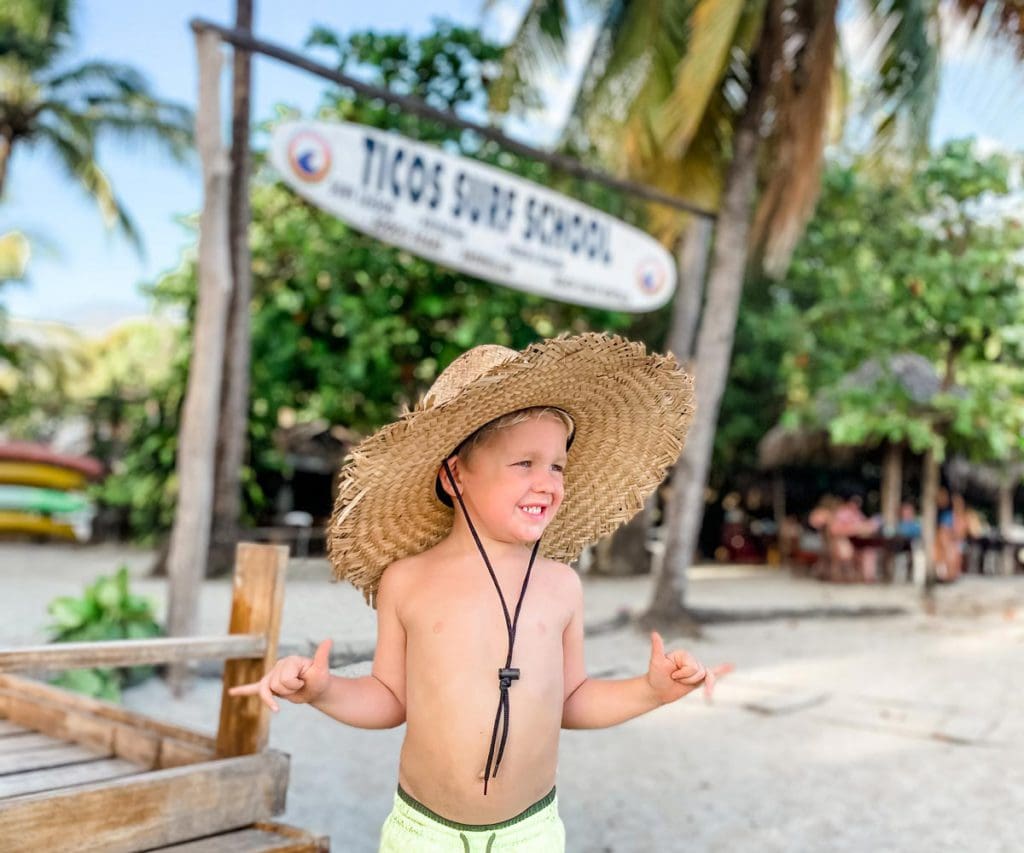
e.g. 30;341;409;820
0;544;1024;853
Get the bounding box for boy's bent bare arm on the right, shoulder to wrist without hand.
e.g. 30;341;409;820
562;569;662;729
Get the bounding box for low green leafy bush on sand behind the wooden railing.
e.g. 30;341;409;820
47;566;164;701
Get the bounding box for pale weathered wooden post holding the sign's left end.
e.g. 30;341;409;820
167;31;231;694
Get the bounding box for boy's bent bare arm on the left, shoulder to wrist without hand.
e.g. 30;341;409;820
311;563;407;729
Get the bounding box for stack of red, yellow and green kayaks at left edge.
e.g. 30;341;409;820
0;442;103;541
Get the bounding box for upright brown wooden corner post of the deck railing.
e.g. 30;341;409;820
217;542;288;757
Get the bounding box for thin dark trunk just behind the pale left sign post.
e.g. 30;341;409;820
207;0;253;574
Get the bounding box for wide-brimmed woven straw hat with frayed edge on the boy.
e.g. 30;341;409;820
327;333;693;606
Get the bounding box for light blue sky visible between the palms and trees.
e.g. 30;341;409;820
0;0;1024;329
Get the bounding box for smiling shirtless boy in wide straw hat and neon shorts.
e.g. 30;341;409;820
232;334;726;853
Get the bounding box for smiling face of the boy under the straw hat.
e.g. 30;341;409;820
446;416;567;542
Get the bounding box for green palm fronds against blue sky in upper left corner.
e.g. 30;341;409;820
0;0;193;248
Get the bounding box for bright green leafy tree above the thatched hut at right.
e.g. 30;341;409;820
774;140;1024;462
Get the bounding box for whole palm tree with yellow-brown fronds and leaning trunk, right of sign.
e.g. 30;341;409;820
493;0;1019;622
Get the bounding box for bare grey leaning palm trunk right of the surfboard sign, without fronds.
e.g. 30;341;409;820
644;19;778;625
